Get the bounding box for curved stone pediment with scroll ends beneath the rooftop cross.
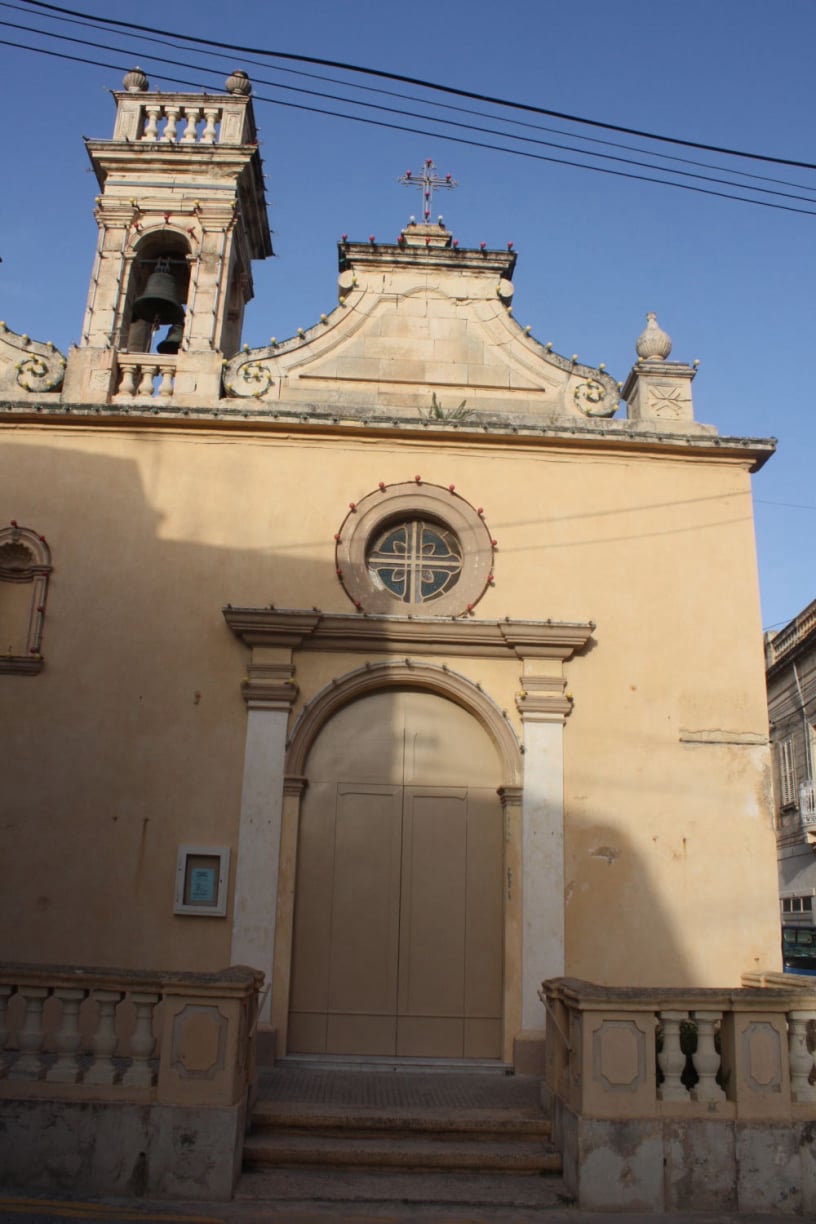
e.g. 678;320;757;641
224;236;619;420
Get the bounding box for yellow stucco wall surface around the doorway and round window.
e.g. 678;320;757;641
0;419;778;985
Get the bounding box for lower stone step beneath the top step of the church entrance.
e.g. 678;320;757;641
243;1130;562;1174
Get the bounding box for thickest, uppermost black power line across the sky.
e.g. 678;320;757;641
19;0;816;170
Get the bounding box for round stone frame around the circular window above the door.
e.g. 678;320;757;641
335;480;495;617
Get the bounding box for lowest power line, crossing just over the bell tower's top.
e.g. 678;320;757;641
0;33;816;217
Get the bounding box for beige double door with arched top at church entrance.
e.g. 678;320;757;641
287;690;504;1058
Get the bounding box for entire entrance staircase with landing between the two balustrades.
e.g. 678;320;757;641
236;1059;570;1207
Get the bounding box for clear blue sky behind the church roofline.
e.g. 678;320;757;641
0;0;816;629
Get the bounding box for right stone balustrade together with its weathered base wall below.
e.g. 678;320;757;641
541;973;816;1219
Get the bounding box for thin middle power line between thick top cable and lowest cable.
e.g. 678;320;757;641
0;20;816;204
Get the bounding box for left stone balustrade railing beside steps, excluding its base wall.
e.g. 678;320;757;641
0;965;262;1104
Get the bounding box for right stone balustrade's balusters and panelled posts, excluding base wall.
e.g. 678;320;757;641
541;974;816;1118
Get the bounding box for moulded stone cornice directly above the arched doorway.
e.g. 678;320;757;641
224;607;595;665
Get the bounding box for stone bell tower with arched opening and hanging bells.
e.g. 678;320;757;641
64;69;273;405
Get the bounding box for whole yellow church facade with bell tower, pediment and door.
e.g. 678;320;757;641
0;71;779;1070
